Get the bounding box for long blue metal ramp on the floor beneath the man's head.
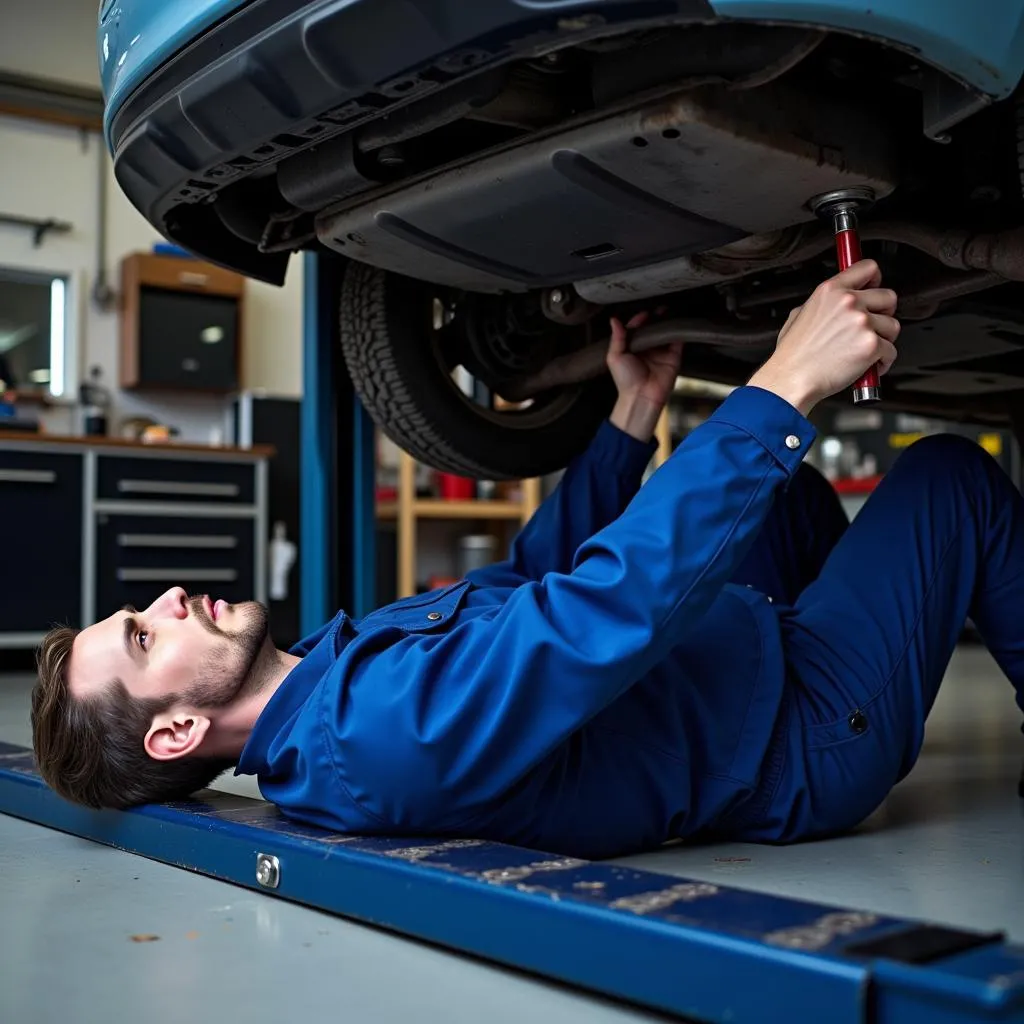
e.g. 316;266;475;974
0;743;1024;1024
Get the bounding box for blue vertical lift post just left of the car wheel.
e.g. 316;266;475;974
299;253;376;636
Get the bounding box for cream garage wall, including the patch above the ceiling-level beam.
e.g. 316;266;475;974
0;0;302;439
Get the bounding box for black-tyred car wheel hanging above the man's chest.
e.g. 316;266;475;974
341;262;614;480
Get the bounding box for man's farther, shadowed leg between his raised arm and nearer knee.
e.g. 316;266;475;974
732;463;849;605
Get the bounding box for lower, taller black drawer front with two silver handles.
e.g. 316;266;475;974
96;512;256;617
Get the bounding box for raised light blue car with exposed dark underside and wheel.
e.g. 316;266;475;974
97;0;1024;479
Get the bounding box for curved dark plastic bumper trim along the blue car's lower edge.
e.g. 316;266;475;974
103;0;715;284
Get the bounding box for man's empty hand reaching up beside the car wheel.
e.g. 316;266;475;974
606;313;683;441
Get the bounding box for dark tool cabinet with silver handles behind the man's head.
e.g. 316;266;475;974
0;438;269;648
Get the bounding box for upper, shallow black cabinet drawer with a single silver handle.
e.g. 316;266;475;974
96;456;256;505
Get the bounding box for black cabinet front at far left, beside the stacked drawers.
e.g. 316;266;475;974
0;451;82;633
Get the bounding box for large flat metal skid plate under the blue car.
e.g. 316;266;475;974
316;84;896;292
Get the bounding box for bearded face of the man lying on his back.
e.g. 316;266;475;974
69;587;268;710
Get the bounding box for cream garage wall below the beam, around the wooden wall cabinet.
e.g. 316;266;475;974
0;118;302;441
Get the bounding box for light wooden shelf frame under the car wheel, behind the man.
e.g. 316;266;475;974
377;452;541;598
